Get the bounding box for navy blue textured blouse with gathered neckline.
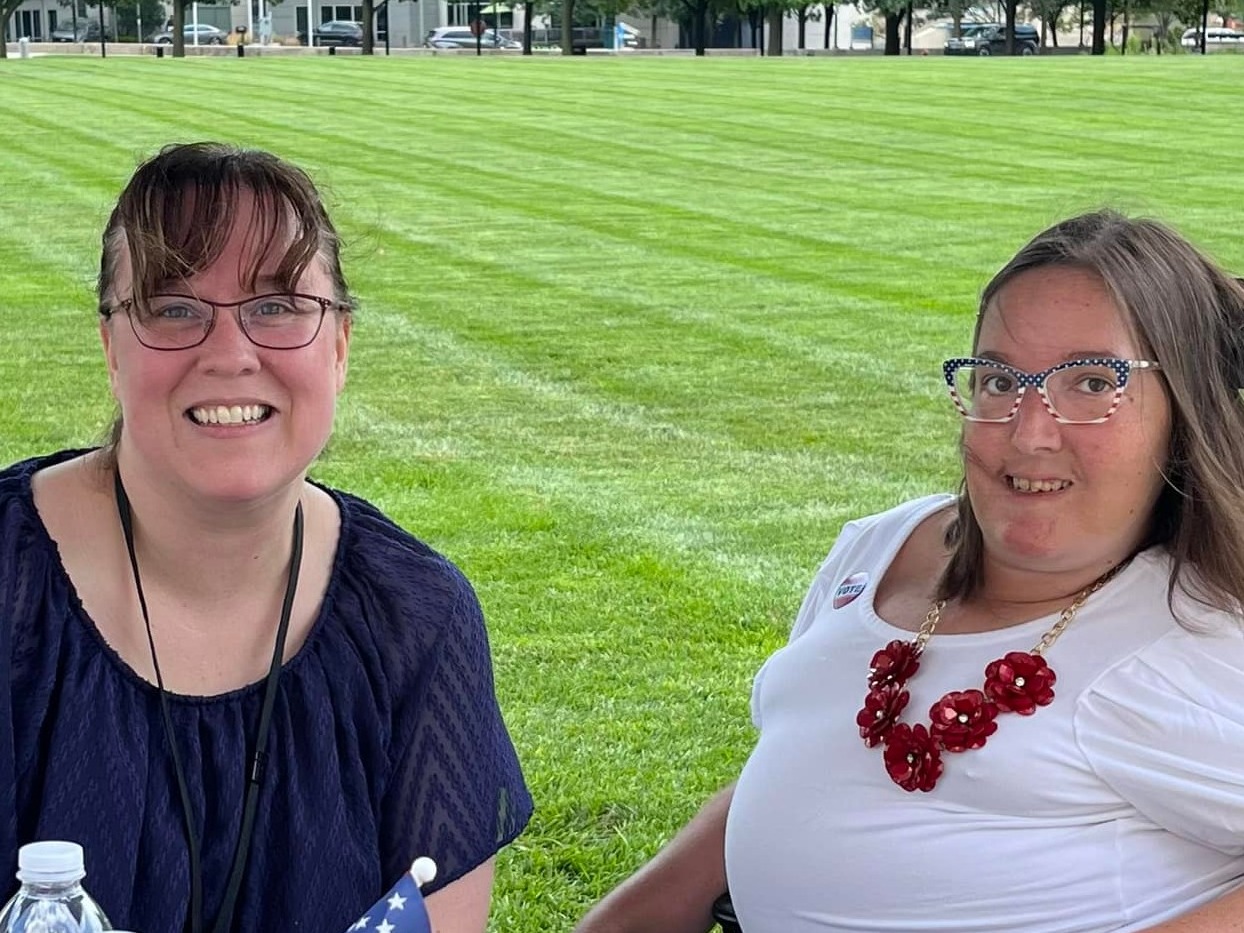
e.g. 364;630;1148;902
0;452;531;933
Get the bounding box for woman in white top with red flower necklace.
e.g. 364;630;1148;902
578;211;1244;933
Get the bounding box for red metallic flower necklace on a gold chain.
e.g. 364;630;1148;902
856;564;1125;791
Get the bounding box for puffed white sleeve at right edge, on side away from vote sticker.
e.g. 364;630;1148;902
1075;626;1244;856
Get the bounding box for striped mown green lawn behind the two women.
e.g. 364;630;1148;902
0;56;1244;933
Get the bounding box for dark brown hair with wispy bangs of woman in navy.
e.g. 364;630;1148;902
97;142;353;454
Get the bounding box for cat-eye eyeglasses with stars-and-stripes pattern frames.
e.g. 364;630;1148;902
942;357;1162;424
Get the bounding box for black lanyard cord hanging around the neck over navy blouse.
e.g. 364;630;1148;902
114;469;302;933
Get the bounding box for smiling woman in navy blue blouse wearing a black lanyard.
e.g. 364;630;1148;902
0;143;531;933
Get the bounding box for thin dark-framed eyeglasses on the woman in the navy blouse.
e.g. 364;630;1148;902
100;292;350;350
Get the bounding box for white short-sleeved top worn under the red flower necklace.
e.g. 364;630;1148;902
725;496;1244;933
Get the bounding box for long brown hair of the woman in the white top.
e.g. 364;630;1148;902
938;210;1244;622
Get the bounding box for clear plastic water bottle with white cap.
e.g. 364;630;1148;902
0;842;112;933
